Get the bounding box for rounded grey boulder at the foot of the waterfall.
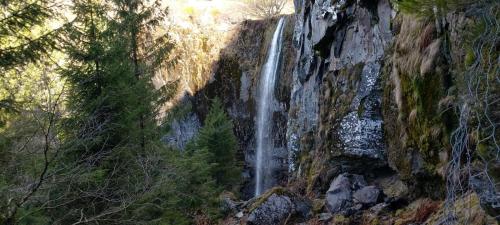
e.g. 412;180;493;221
247;193;295;225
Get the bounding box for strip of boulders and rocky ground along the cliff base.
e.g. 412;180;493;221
221;173;497;225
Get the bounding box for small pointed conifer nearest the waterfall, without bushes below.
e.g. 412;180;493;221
188;98;241;189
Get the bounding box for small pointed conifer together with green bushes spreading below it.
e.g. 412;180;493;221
133;99;240;224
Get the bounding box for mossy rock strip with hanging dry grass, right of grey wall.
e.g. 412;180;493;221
383;15;454;198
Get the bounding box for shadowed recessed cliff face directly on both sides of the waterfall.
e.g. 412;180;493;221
189;16;295;198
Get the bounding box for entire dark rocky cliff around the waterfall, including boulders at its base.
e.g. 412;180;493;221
167;0;498;224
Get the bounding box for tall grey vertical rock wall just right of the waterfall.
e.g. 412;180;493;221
287;0;393;191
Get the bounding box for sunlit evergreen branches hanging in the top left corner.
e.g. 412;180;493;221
0;0;63;70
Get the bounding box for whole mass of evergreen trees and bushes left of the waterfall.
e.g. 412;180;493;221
0;0;240;224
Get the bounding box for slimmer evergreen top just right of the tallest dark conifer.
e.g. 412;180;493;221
111;0;172;151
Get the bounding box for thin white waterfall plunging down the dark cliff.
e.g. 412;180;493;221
255;18;284;196
